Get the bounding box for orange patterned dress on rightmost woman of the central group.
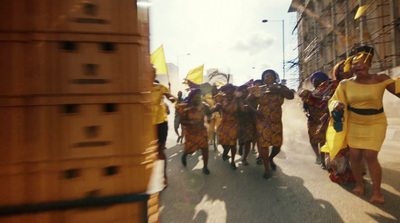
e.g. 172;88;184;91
254;88;284;148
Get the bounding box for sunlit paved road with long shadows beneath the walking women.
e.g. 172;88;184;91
160;96;400;223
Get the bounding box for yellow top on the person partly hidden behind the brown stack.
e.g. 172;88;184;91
151;84;169;125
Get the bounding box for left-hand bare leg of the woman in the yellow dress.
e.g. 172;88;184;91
350;148;364;195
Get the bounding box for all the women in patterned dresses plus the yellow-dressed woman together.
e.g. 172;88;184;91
176;46;400;203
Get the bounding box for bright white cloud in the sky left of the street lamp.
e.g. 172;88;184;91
232;32;275;55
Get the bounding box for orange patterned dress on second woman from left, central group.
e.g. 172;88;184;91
214;94;239;146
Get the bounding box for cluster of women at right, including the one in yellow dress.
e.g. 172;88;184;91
300;46;400;203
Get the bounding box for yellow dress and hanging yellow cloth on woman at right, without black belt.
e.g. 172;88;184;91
321;79;394;159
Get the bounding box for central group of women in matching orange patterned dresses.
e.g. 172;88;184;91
176;70;294;179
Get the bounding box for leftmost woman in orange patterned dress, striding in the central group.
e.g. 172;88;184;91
175;89;210;175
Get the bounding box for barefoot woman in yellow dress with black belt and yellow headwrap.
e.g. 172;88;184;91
327;46;400;203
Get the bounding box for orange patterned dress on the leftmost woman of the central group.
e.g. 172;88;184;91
175;103;208;153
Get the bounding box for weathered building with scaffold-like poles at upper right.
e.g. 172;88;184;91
289;0;400;86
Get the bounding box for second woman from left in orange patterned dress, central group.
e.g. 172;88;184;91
213;84;239;170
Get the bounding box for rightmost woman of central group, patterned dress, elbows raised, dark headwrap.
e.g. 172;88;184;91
248;70;294;179
